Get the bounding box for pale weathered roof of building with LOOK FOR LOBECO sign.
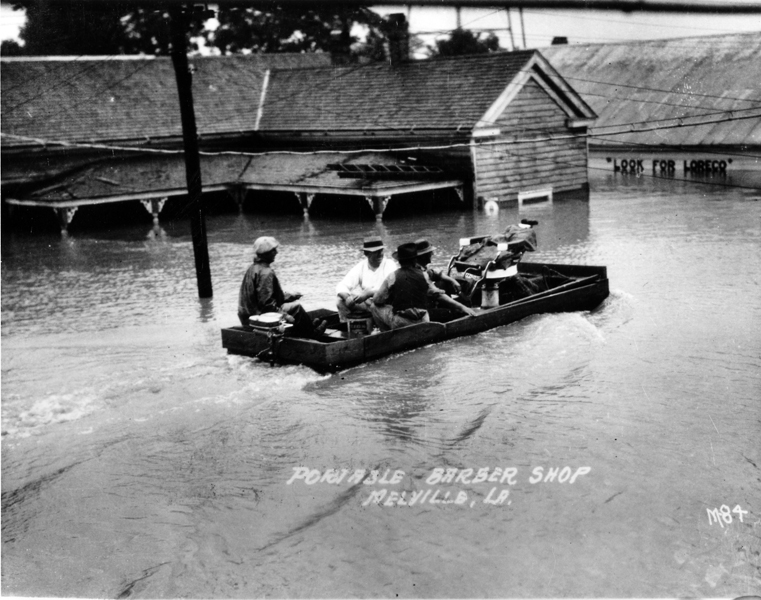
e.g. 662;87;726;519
542;33;761;146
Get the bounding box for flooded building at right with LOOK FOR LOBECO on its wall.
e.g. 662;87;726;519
542;32;761;178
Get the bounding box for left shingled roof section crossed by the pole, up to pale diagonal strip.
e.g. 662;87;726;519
0;53;330;148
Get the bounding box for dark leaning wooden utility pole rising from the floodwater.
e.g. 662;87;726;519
170;6;213;298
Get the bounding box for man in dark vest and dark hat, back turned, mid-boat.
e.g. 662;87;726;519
370;242;475;331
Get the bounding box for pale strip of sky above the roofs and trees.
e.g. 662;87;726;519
0;3;761;50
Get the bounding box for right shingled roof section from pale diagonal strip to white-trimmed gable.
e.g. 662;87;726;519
257;50;594;132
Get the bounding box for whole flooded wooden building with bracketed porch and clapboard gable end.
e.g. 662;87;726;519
1;45;595;228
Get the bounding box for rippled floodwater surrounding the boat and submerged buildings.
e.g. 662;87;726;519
2;171;761;598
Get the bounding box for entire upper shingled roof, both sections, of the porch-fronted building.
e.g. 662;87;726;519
2;50;595;148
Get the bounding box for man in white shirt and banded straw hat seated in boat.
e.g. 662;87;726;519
336;237;399;322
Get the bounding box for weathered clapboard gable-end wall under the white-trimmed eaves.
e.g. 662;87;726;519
475;80;588;200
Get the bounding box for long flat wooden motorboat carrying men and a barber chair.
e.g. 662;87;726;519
222;262;609;372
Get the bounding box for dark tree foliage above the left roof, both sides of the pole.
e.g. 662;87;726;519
2;0;382;59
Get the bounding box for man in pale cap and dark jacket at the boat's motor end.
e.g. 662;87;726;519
238;236;327;338
